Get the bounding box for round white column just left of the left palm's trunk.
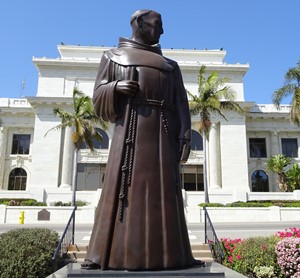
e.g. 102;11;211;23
60;127;74;189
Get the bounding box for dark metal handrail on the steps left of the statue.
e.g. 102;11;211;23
52;206;77;267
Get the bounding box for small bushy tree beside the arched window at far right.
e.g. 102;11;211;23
266;154;292;192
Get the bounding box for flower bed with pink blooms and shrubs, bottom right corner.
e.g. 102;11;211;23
220;228;300;278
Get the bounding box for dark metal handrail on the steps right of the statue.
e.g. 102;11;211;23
203;207;225;263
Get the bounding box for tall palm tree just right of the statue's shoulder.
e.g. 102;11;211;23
187;65;243;203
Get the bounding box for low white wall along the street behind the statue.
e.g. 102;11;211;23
0;205;300;224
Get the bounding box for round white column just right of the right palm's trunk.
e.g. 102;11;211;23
208;123;222;189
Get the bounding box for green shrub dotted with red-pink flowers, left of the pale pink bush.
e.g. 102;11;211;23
231;236;282;277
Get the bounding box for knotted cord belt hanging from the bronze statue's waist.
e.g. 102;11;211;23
119;99;174;222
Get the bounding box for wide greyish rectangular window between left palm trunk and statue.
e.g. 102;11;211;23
77;163;105;191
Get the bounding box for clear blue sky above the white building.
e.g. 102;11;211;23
0;0;300;103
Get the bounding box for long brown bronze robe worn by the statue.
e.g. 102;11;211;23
86;38;194;270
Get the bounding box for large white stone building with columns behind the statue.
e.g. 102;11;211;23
0;45;300;207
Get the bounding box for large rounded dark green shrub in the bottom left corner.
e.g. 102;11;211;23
0;228;59;278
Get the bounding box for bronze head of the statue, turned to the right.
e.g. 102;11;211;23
130;10;164;45
